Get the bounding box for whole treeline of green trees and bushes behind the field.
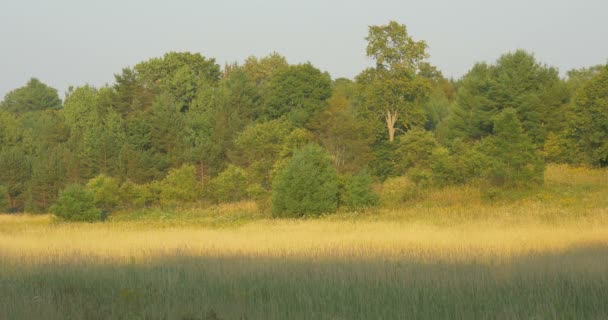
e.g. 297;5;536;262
0;22;608;220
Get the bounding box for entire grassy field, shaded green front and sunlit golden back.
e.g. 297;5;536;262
0;166;608;320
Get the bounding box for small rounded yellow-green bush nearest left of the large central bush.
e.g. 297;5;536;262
209;164;247;203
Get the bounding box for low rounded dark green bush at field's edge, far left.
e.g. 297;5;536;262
50;184;101;222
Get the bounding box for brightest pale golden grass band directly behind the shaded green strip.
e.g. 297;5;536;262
0;216;608;262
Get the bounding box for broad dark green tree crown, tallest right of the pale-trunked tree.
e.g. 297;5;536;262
443;50;569;145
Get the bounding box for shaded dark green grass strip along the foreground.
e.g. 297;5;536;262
0;247;608;320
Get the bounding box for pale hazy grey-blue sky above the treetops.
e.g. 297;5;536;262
0;0;608;99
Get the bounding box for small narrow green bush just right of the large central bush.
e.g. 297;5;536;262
344;170;379;211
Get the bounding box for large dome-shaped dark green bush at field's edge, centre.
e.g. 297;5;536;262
272;145;338;217
